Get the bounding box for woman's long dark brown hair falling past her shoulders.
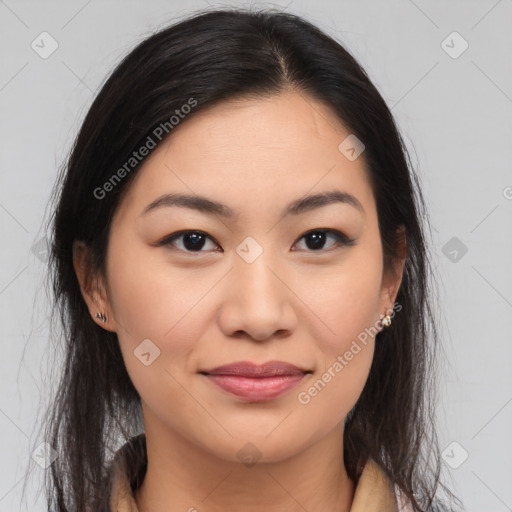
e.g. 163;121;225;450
34;8;462;512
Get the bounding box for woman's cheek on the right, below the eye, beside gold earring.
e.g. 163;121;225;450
297;246;382;424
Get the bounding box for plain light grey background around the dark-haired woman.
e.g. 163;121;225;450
0;0;512;512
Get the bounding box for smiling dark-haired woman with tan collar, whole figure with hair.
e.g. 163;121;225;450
36;9;460;512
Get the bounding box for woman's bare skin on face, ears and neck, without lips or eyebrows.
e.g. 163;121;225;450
74;91;403;512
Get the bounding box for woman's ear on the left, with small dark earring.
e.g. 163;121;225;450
73;240;116;332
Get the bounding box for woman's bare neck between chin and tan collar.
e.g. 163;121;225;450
135;416;355;512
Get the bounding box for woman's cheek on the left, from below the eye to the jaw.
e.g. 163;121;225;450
104;241;212;421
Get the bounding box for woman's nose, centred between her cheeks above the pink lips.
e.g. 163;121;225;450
218;252;297;341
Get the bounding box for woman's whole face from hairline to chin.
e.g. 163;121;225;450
74;92;399;461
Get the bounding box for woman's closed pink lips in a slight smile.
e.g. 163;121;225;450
200;361;311;402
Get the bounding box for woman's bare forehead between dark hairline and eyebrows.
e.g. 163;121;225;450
114;92;373;222
